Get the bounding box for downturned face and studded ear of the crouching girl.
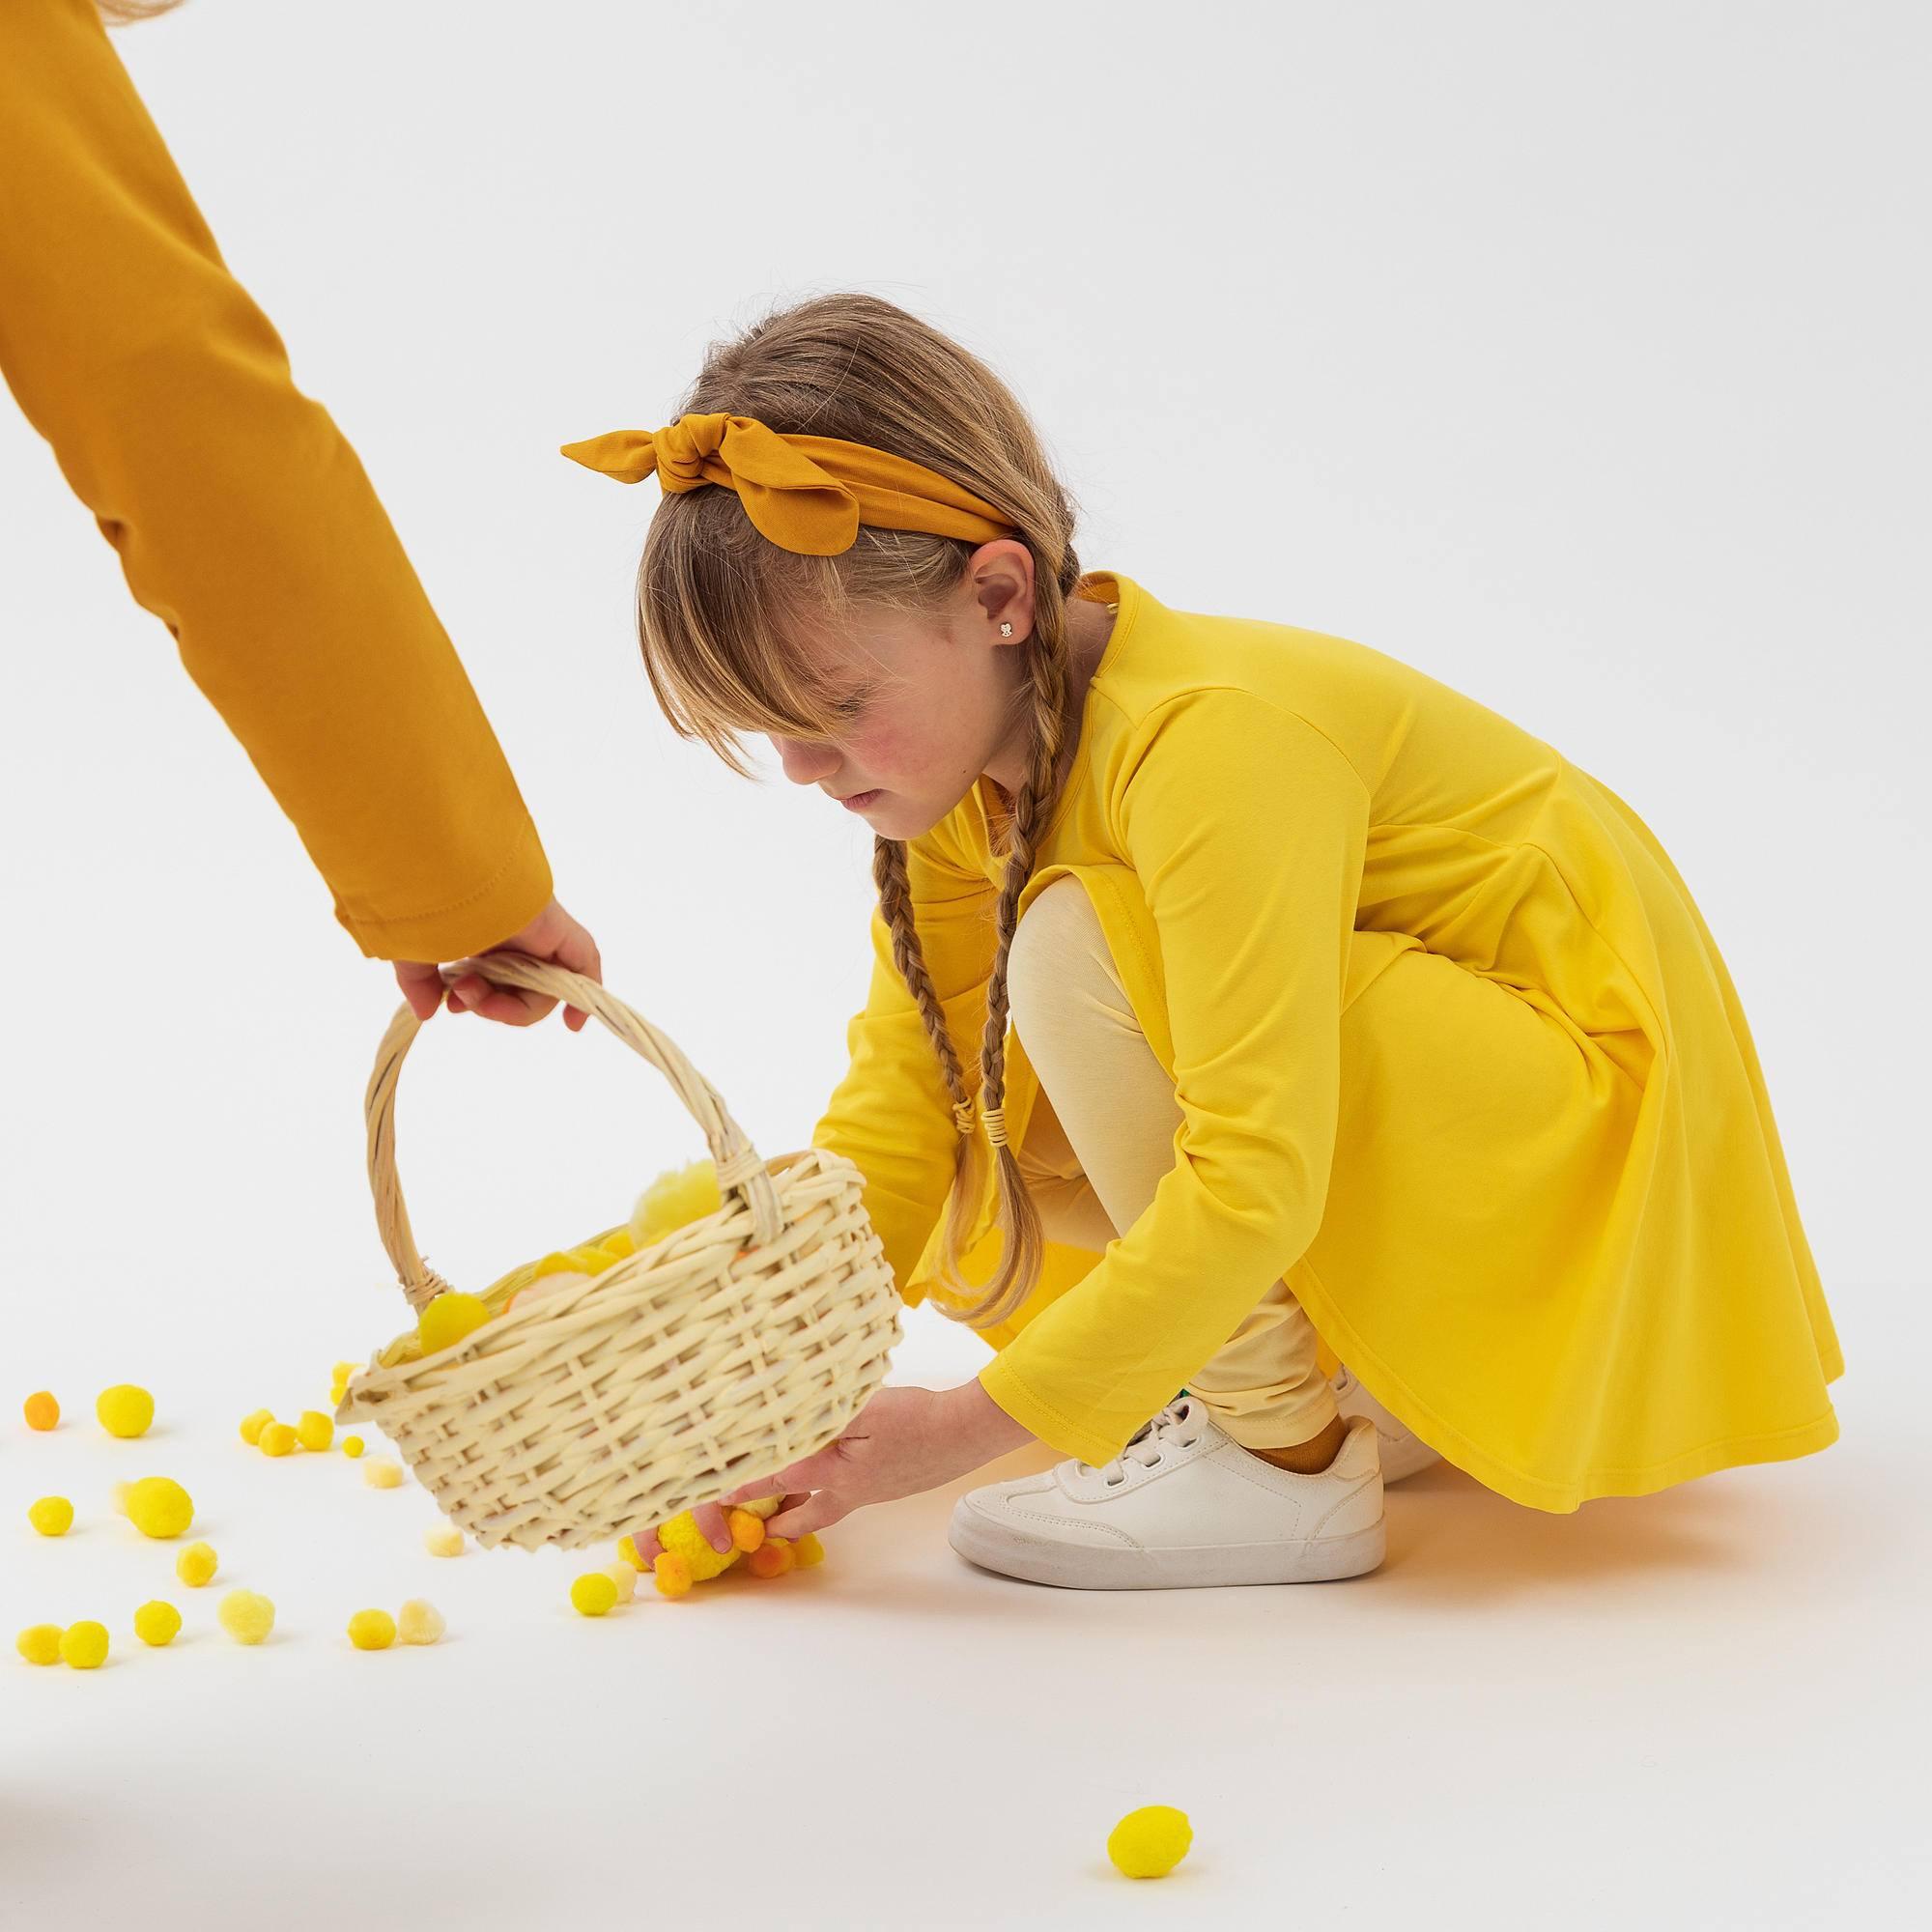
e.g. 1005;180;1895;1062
771;539;1034;838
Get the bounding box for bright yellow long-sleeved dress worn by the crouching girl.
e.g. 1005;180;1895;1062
813;574;1843;1511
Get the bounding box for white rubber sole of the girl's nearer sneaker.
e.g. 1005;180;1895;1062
947;1503;1389;1590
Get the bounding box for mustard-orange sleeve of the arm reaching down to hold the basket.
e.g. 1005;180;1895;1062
0;0;551;960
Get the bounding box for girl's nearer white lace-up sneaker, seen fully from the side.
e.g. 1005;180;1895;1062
947;1395;1385;1590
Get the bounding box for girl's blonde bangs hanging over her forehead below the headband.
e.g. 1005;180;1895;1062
638;491;846;777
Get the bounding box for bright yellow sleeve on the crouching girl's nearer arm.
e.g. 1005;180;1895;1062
980;690;1368;1463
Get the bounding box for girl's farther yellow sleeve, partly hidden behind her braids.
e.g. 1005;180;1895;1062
811;835;997;1302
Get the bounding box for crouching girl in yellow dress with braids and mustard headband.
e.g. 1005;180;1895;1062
566;296;1843;1588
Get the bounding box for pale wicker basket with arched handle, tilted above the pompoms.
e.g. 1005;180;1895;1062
336;952;900;1549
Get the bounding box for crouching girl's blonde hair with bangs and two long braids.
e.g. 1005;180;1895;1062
638;294;1080;1327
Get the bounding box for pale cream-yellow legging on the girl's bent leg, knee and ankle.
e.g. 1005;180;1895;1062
1007;877;1335;1449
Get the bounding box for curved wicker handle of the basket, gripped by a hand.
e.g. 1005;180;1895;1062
363;952;782;1310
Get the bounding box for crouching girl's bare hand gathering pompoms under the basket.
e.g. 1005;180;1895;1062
711;1381;1032;1551
